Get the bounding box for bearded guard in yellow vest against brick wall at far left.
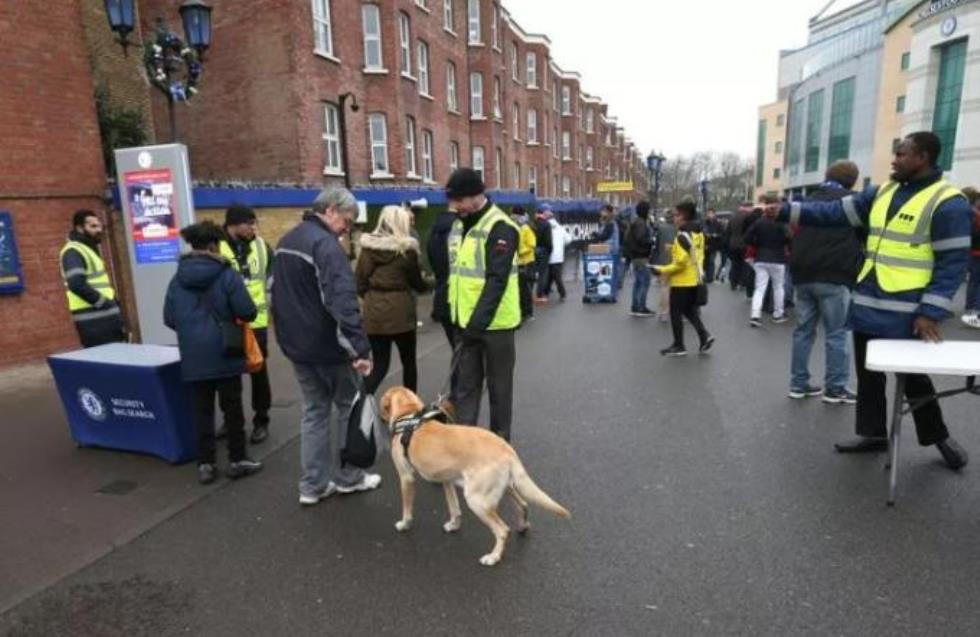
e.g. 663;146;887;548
60;210;126;347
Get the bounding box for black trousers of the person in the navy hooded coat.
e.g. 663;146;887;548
190;376;245;464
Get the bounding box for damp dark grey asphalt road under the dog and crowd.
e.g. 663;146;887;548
0;274;980;636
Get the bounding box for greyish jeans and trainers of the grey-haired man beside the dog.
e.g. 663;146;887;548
293;363;364;495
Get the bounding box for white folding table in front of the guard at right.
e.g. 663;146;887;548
865;339;980;506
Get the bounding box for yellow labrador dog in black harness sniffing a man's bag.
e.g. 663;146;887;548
381;387;570;566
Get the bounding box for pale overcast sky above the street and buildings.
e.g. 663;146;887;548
503;0;854;157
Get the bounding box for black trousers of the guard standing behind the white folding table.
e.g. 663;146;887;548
854;332;949;447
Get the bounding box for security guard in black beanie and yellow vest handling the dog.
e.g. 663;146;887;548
446;168;521;440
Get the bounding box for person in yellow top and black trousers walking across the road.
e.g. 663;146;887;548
651;201;715;356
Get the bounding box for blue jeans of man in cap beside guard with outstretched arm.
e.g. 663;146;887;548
790;283;851;390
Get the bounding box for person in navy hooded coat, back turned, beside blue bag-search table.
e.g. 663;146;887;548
163;221;262;484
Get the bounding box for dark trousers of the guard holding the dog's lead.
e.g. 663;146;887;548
456;330;516;440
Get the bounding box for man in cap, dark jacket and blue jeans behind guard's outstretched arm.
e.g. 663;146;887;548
789;160;864;404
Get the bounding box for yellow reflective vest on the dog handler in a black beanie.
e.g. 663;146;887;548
449;206;521;331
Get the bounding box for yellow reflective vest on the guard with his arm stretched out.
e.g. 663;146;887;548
858;179;962;292
